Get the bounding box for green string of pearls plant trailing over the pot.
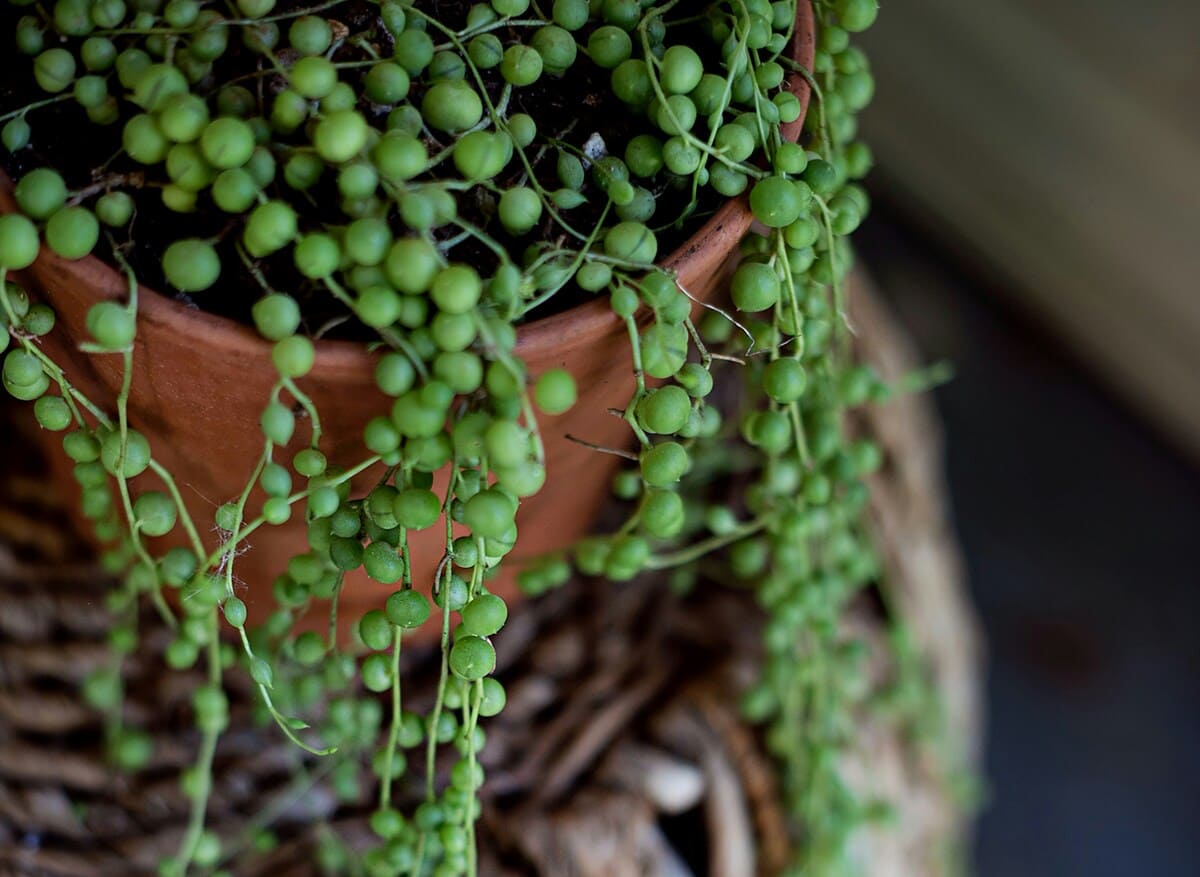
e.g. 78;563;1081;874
0;0;945;877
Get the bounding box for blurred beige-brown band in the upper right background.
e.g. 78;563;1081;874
864;0;1200;459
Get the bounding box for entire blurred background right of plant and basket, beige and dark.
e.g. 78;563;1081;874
857;0;1200;877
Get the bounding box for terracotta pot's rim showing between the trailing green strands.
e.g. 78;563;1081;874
0;0;815;371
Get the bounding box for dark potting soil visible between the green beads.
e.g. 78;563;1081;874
0;0;718;340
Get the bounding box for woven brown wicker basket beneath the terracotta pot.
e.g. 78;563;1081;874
0;271;980;877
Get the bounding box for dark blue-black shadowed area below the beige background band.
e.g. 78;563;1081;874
857;206;1200;877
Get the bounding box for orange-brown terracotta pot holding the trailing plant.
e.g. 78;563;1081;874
0;2;814;643
